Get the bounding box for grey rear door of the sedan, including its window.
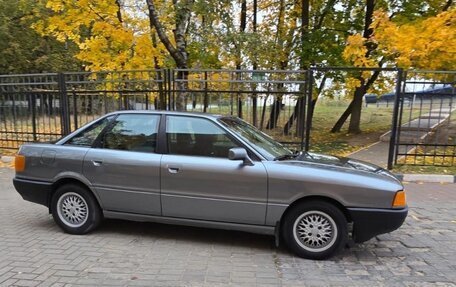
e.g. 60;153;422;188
83;114;162;215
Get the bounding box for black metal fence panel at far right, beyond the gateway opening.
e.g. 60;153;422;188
391;71;456;166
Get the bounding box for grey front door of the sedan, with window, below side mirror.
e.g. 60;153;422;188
161;115;267;224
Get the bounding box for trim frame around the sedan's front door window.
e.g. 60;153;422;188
161;114;261;161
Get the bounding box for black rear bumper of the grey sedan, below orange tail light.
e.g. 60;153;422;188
13;178;52;207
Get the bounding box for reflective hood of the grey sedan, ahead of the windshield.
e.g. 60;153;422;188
292;152;399;181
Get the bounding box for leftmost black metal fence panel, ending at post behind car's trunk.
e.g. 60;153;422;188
0;74;62;148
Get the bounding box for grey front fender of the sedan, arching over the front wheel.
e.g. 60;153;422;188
265;162;403;224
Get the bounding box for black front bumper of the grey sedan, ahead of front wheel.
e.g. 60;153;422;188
348;207;408;243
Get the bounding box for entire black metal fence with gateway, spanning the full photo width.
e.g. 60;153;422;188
0;68;456;168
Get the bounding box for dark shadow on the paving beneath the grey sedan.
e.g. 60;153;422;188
30;215;378;263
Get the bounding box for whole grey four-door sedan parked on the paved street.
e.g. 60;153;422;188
13;111;408;259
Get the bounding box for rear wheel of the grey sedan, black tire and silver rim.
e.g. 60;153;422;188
51;184;103;234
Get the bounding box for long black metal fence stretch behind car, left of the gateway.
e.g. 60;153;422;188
0;70;308;149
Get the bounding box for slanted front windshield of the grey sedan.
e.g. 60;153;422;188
219;118;294;160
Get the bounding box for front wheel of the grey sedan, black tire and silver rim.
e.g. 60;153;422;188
282;200;348;260
